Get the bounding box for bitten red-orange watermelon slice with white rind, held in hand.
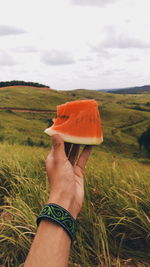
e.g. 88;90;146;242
45;100;103;145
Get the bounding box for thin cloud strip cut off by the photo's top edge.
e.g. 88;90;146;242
71;0;118;7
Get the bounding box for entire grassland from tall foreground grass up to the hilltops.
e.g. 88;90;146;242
0;88;150;267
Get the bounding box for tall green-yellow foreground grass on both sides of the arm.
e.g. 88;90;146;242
0;143;150;267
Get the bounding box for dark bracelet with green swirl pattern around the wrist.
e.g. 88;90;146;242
37;203;77;241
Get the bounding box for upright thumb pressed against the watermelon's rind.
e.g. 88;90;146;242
52;134;66;160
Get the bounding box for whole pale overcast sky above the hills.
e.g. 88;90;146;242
0;0;150;90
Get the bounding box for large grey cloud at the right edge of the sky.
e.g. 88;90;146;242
98;26;150;49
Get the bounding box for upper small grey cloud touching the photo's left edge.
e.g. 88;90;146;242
0;25;26;36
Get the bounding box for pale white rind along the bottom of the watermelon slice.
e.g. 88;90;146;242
44;127;103;145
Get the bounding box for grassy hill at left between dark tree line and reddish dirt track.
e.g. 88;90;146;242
0;86;70;110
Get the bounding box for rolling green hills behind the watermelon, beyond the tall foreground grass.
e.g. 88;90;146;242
0;86;150;155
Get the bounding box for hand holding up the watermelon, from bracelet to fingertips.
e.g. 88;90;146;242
46;135;92;218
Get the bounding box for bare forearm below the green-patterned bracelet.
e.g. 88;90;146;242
24;220;71;267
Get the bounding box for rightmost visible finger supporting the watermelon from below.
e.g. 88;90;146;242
76;145;92;171
